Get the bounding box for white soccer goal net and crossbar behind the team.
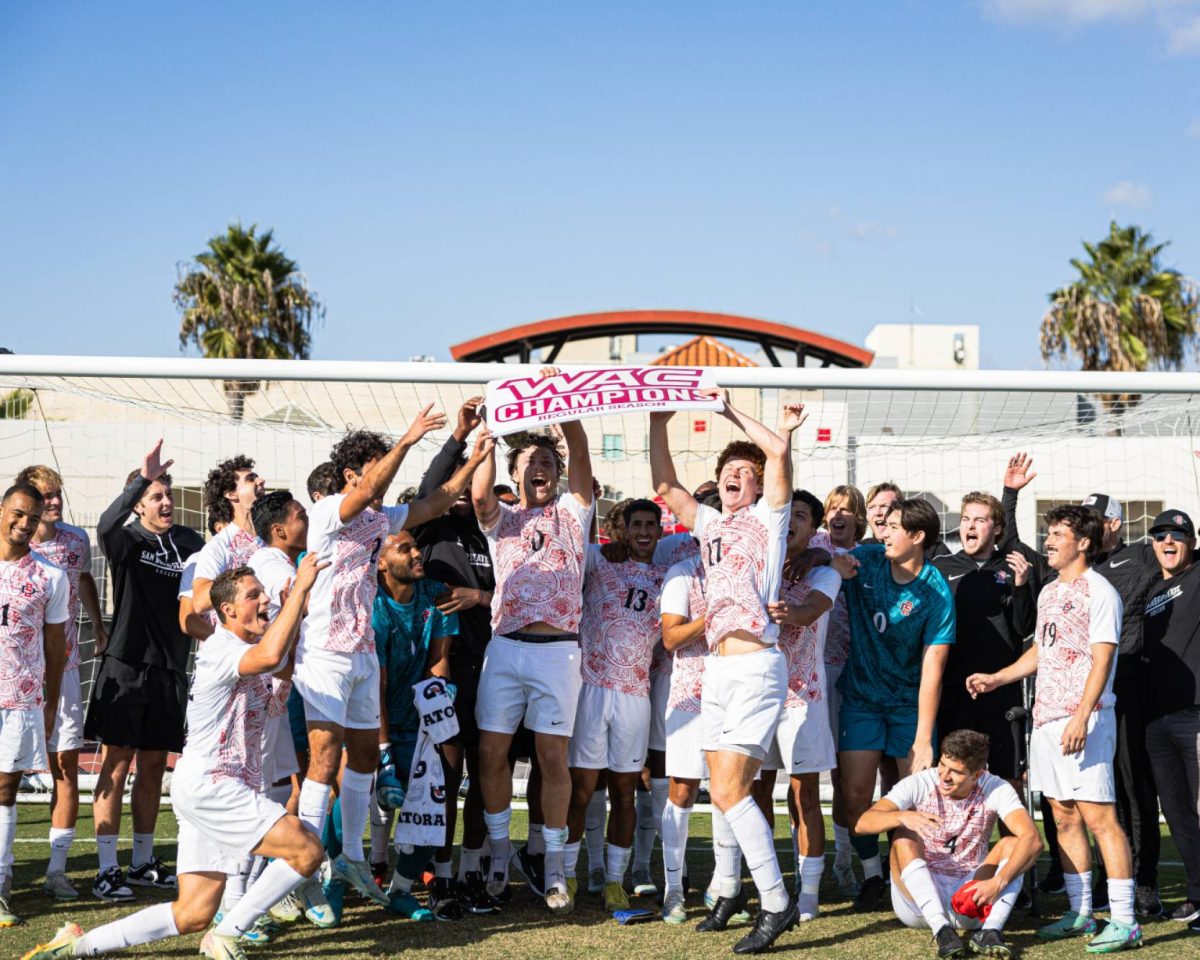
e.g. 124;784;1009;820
0;356;1200;788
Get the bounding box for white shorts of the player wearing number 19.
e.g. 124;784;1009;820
1030;708;1117;803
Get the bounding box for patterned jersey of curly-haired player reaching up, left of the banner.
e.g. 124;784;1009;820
300;493;408;653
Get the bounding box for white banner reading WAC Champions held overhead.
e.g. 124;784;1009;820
485;367;725;437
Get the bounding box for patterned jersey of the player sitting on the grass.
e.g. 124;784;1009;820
886;767;1025;880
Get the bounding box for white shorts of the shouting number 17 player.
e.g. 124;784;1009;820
700;647;787;761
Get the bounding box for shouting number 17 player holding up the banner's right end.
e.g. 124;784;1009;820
649;400;803;953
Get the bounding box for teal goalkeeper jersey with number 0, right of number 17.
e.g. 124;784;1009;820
838;544;954;710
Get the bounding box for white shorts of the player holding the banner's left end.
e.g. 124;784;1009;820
475;636;583;737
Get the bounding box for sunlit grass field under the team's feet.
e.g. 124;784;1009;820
0;804;1200;960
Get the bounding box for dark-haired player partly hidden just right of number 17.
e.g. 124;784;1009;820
770;490;853;920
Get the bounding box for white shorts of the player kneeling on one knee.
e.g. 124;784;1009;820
170;761;288;874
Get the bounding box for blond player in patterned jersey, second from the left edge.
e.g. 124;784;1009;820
16;464;108;900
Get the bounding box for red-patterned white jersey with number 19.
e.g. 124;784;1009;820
1033;568;1121;726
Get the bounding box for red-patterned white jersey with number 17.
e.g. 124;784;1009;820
694;498;792;650
